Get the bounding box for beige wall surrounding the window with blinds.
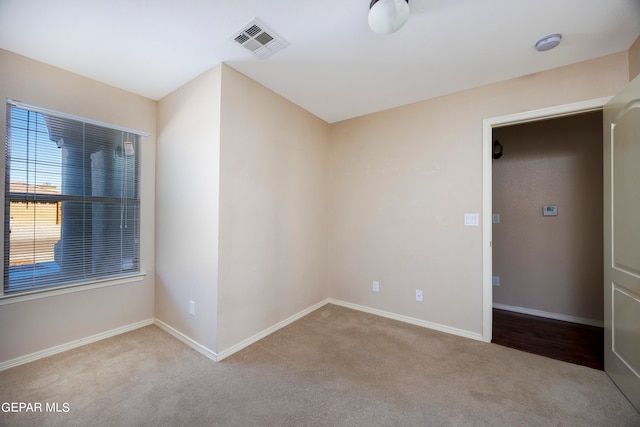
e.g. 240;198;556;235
0;50;156;362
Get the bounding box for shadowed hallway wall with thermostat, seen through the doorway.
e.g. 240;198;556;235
493;111;604;321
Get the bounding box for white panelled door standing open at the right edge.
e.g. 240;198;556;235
604;77;640;411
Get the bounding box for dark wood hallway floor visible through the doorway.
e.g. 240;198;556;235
492;309;604;370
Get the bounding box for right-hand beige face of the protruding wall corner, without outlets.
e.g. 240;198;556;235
218;65;329;350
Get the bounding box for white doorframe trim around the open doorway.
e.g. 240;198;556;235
482;96;613;343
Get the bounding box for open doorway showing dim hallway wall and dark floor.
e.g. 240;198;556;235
492;111;604;370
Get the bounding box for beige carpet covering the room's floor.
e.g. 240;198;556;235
0;305;640;427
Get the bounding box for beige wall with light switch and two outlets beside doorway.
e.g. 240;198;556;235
328;52;628;335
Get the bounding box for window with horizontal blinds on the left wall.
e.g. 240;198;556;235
4;101;143;294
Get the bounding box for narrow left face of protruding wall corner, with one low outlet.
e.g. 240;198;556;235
155;66;221;353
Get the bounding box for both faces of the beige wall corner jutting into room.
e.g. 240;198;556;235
156;65;328;354
